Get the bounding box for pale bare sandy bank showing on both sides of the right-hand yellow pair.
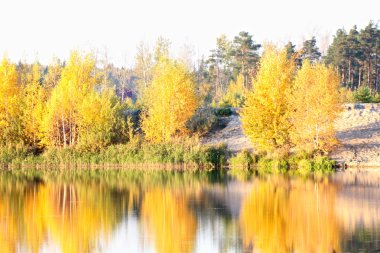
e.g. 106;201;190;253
203;104;380;167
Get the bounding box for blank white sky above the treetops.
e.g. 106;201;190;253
0;0;380;67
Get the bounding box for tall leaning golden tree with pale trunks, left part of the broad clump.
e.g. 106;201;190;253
44;52;96;147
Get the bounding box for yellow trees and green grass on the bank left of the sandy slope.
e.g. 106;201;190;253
0;52;227;168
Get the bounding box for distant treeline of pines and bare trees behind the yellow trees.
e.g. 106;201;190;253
7;21;380;106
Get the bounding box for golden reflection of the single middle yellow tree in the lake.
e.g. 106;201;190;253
142;188;196;253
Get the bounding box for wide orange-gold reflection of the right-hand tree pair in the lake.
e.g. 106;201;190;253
240;180;340;253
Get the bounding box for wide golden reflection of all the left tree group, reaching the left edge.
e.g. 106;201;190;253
0;183;124;253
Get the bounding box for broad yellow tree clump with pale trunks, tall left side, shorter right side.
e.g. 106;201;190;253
44;52;118;149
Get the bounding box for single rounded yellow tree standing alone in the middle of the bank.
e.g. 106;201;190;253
142;59;197;142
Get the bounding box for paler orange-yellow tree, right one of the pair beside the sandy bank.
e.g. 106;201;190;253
289;60;341;153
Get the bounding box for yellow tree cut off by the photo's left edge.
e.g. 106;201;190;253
0;57;22;144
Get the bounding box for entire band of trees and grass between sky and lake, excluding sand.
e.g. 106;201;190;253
0;20;380;168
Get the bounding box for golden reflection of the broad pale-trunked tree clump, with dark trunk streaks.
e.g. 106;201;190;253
40;185;122;253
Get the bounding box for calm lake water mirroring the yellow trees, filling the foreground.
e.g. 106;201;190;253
0;170;380;253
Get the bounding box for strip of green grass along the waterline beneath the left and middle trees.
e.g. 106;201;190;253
0;141;227;169
